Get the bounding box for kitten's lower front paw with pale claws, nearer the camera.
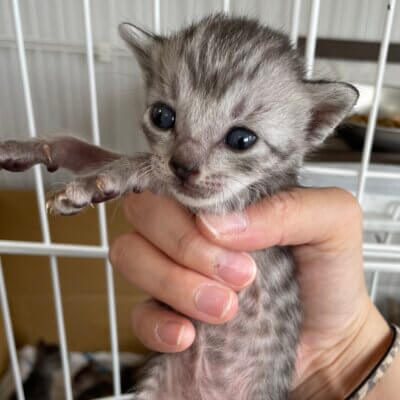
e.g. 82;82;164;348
46;173;121;215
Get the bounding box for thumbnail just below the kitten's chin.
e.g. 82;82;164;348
200;213;248;236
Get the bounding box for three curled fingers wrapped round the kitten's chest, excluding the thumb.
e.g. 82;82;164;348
110;192;256;352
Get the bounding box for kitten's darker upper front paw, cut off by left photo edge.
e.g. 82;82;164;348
0;139;57;172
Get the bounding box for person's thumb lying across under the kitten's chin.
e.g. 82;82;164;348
197;188;362;251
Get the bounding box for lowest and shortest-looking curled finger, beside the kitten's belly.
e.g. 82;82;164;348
132;300;196;353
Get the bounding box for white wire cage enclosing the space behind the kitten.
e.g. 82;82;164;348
0;0;400;400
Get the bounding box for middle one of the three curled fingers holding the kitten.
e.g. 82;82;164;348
110;233;237;324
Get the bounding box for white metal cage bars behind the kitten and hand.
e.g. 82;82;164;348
0;0;400;400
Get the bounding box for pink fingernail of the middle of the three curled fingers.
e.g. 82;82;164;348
195;285;232;318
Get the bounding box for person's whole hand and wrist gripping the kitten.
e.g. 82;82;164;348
110;188;400;400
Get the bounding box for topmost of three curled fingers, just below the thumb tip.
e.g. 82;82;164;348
124;192;256;290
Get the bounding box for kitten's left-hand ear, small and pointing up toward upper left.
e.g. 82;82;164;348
119;22;162;70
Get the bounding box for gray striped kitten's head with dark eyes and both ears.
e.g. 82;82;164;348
120;15;358;211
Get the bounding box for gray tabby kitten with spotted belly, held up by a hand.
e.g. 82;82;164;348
0;15;358;400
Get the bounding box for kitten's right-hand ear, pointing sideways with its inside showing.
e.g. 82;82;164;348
304;81;359;147
